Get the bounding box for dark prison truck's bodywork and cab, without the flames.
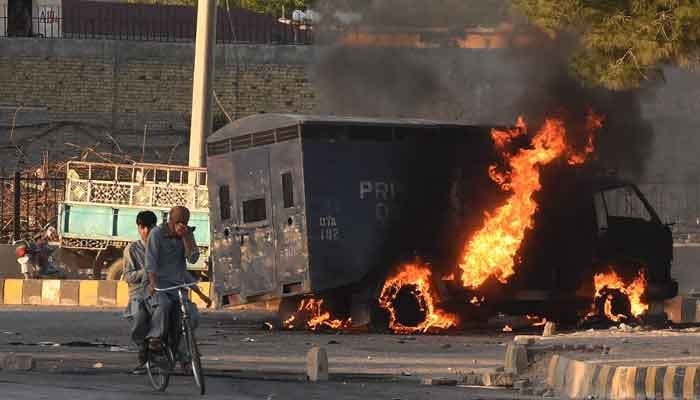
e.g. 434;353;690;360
207;114;677;323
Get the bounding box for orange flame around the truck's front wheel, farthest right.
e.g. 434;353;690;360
593;269;649;322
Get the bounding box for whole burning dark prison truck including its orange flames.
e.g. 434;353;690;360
208;112;677;333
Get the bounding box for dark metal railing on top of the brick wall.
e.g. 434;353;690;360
0;0;313;44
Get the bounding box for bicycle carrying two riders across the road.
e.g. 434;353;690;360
146;282;205;395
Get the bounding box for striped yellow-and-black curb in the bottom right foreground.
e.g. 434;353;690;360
546;354;700;400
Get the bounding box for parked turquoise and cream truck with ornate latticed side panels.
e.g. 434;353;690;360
57;161;209;279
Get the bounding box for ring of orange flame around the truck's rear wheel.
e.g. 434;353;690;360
379;264;458;333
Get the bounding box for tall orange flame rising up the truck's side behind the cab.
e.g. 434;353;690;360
459;112;602;289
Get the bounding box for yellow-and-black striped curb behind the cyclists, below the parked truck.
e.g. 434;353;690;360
0;279;211;308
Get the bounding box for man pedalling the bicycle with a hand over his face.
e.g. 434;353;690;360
146;206;211;351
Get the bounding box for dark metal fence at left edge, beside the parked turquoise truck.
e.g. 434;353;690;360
0;172;65;243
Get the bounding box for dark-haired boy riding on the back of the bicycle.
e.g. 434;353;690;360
123;211;158;372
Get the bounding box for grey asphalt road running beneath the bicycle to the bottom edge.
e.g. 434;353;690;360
0;307;522;400
